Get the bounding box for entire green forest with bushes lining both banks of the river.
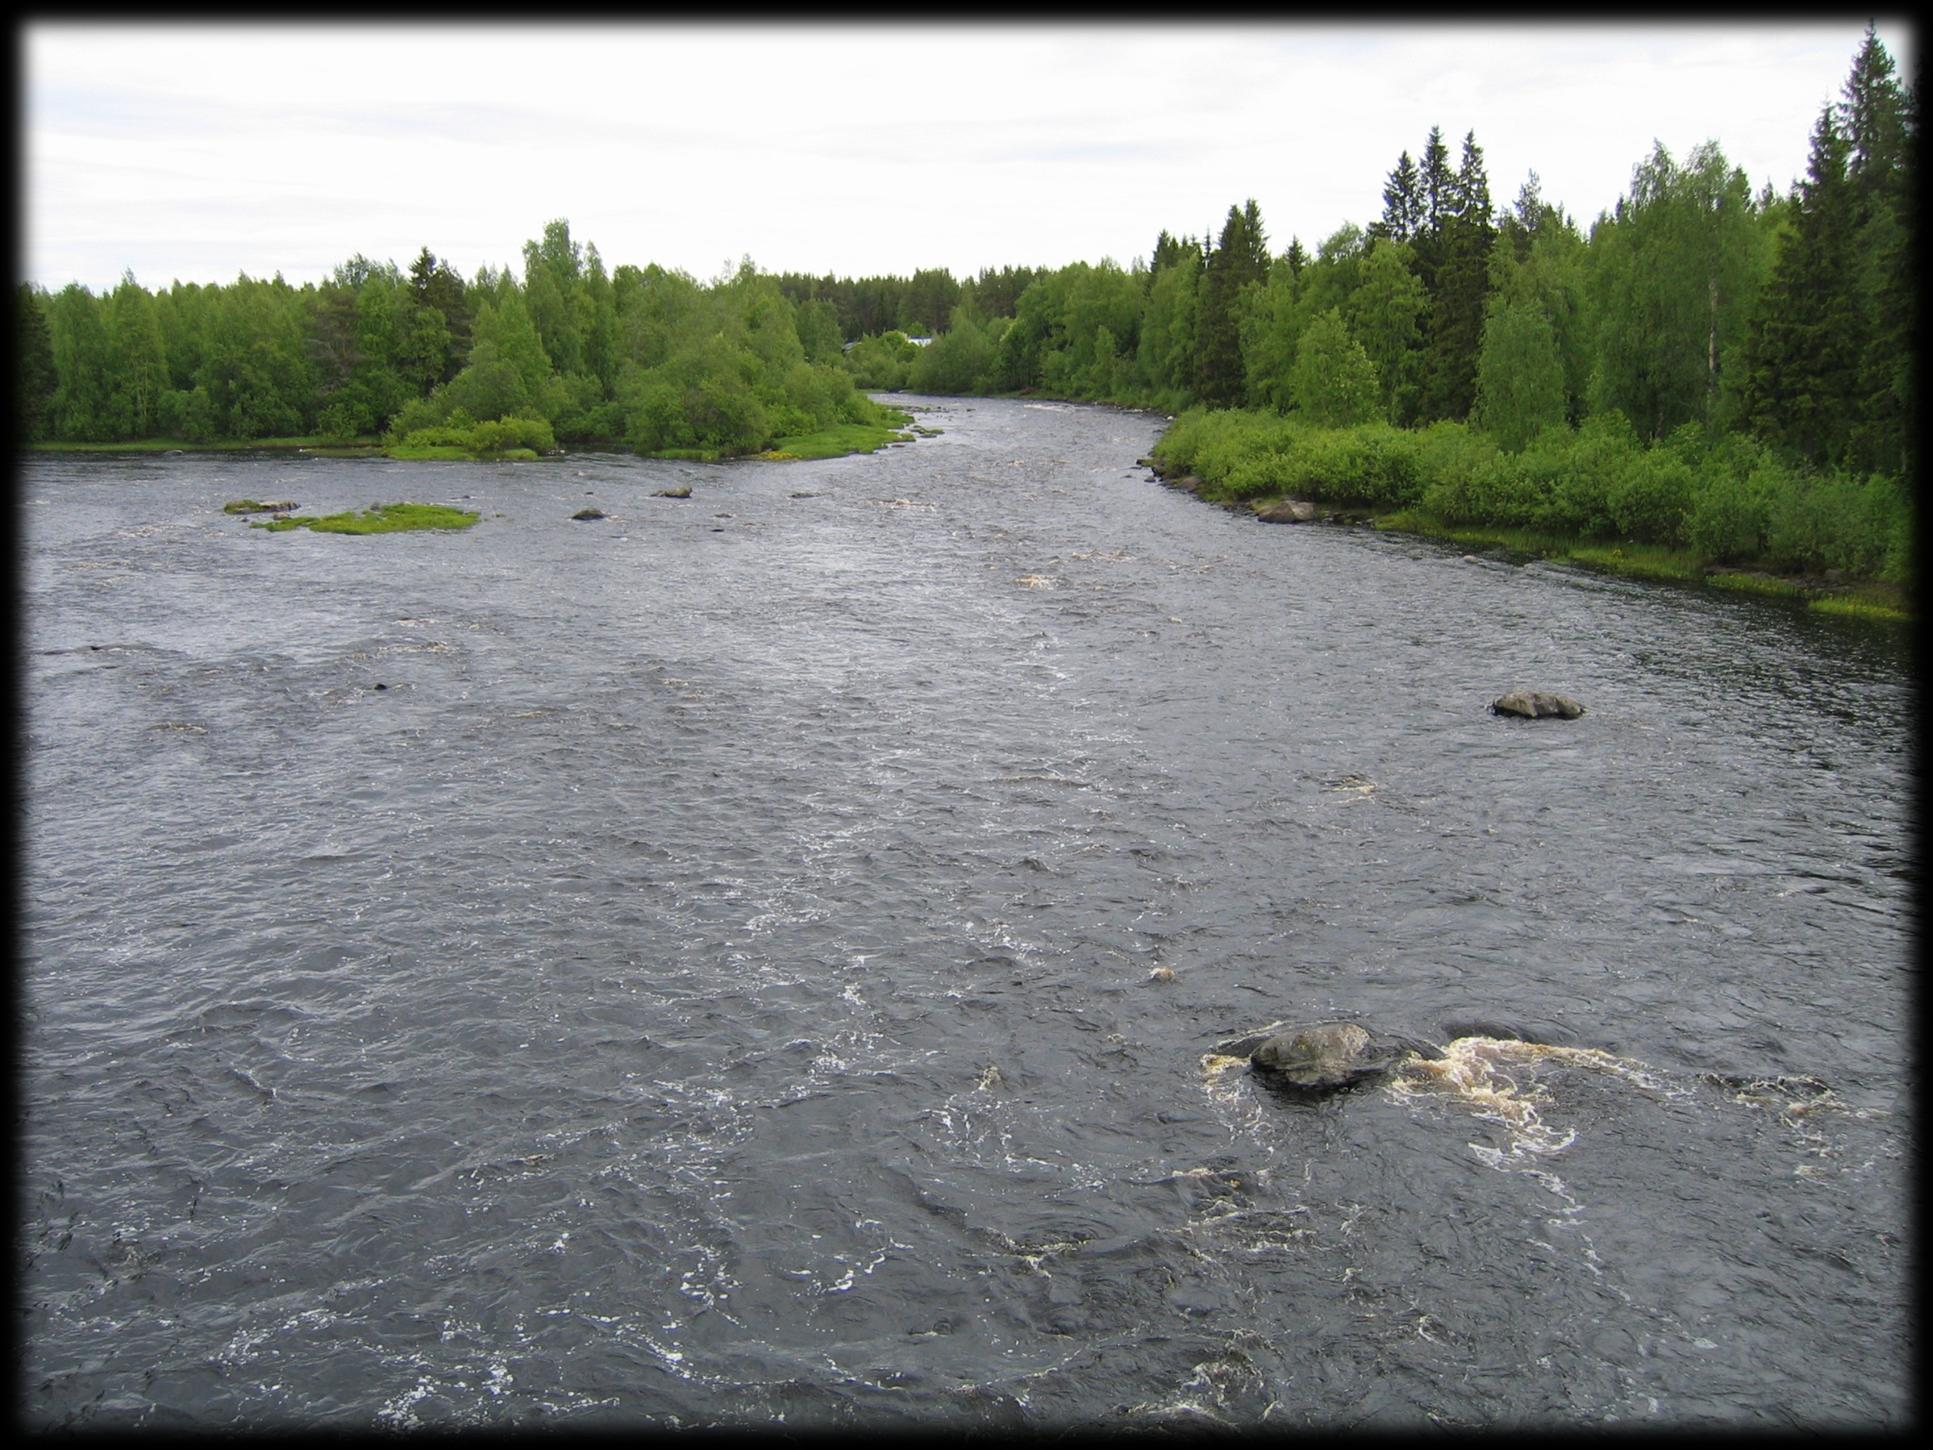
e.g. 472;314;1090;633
15;27;1918;586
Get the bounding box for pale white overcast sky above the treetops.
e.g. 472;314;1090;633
19;10;1916;292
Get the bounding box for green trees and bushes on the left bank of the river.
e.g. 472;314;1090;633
15;220;900;458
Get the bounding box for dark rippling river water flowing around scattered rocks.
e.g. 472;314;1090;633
15;398;1916;1429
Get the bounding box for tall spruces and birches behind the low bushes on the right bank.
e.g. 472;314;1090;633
907;31;1918;474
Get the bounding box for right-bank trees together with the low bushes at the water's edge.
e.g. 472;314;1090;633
893;27;1919;582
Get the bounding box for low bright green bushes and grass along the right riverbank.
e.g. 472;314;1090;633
1144;410;1914;623
